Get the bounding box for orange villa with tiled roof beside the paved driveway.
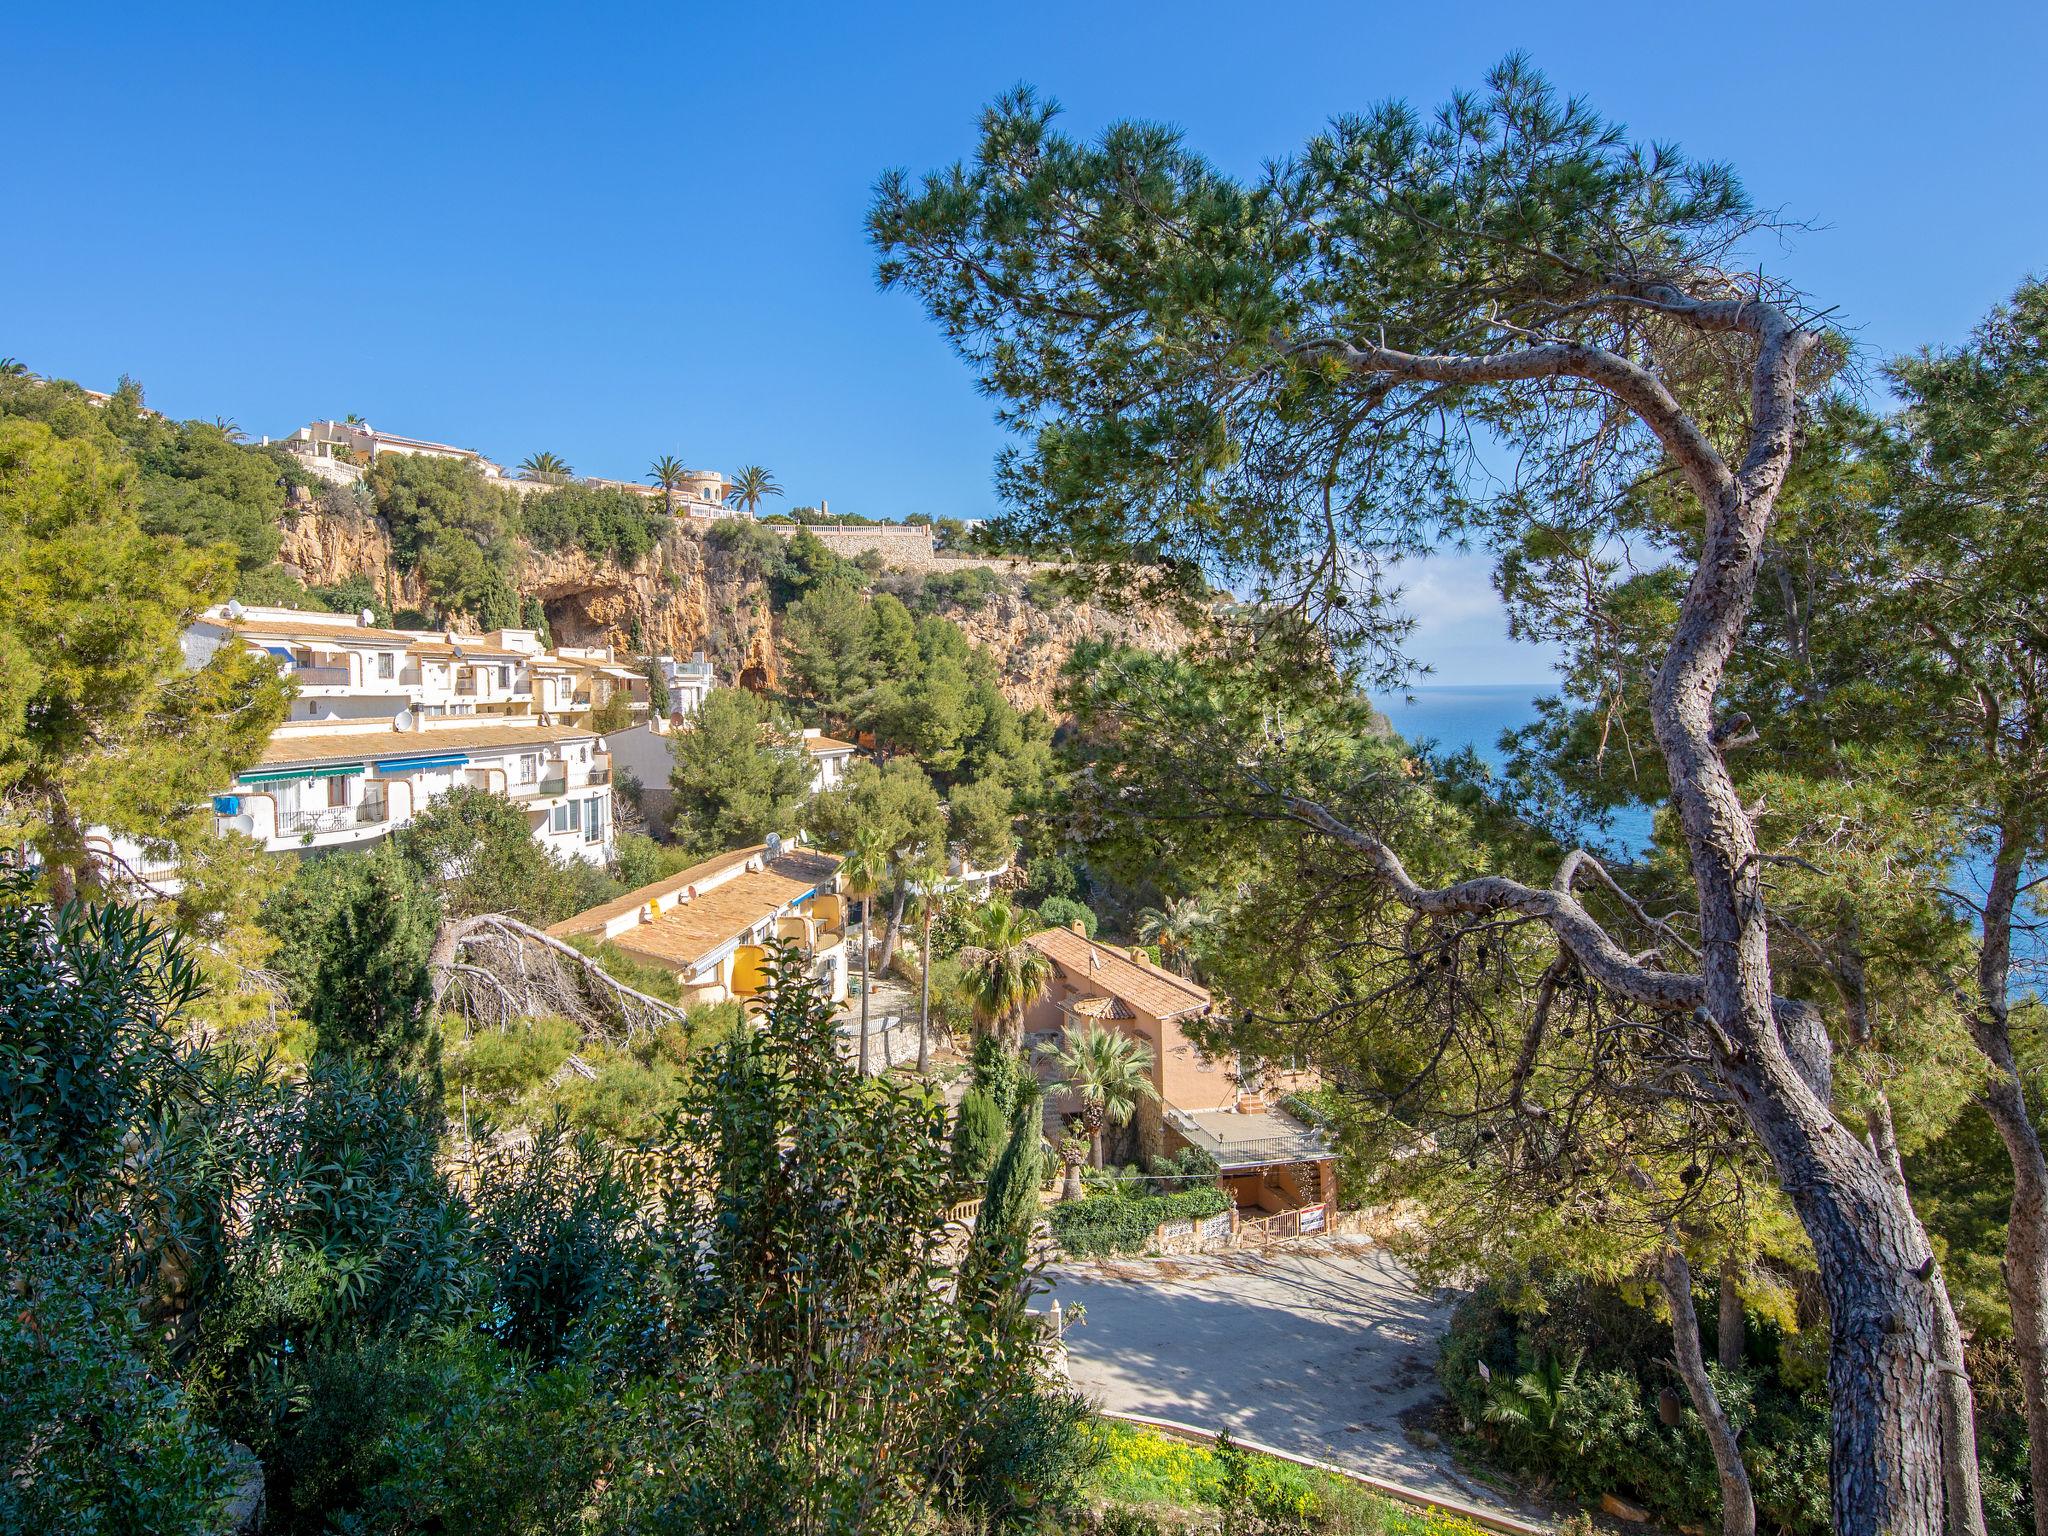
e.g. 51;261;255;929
1024;928;1337;1214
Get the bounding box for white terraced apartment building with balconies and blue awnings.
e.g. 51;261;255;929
184;604;618;862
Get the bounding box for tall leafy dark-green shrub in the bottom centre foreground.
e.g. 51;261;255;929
614;963;1079;1532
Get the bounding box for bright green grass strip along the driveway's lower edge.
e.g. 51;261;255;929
1087;1419;1493;1536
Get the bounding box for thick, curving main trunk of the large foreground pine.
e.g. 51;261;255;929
1651;460;1944;1536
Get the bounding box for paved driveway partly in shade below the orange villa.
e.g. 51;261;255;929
1051;1237;1507;1509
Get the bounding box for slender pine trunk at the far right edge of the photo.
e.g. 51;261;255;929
1970;843;2048;1536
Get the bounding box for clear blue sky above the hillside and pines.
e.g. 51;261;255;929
0;0;2048;682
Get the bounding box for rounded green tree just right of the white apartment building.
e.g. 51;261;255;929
670;684;811;856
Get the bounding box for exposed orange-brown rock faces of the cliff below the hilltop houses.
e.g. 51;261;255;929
279;510;1186;709
